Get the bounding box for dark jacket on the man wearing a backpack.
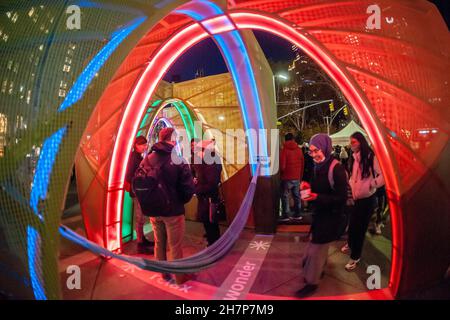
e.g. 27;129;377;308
141;141;194;216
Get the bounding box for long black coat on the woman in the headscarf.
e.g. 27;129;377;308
311;157;348;244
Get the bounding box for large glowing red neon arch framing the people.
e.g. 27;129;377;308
77;2;446;298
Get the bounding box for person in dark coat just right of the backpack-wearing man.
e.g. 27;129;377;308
193;140;222;246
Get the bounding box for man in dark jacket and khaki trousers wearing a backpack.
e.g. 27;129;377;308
141;128;194;284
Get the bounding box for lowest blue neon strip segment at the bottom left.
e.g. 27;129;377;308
27;226;47;300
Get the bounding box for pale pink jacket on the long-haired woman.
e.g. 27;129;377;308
349;152;384;200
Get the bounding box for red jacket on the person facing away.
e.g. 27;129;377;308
280;140;305;180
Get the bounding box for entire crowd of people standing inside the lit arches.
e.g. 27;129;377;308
125;128;386;297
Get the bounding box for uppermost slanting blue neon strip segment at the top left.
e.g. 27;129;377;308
58;17;146;111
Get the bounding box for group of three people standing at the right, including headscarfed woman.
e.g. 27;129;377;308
280;132;386;297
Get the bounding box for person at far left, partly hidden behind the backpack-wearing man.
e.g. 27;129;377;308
125;136;155;254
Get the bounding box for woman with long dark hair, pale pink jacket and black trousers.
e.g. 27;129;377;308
341;132;384;271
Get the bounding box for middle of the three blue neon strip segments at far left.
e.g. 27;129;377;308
30;127;67;220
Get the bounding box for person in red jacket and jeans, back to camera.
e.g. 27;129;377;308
280;133;305;220
